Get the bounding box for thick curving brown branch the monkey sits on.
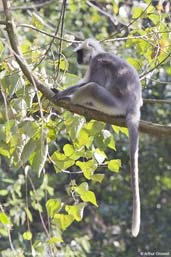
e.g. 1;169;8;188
2;0;171;137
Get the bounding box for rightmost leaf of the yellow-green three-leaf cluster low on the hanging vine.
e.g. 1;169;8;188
65;203;85;221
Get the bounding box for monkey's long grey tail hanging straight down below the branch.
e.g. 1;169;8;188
126;115;140;237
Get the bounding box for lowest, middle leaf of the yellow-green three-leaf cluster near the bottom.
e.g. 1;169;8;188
54;213;74;230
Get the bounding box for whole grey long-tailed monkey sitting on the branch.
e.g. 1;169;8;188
55;39;143;237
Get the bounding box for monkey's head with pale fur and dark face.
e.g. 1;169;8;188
74;38;104;64
